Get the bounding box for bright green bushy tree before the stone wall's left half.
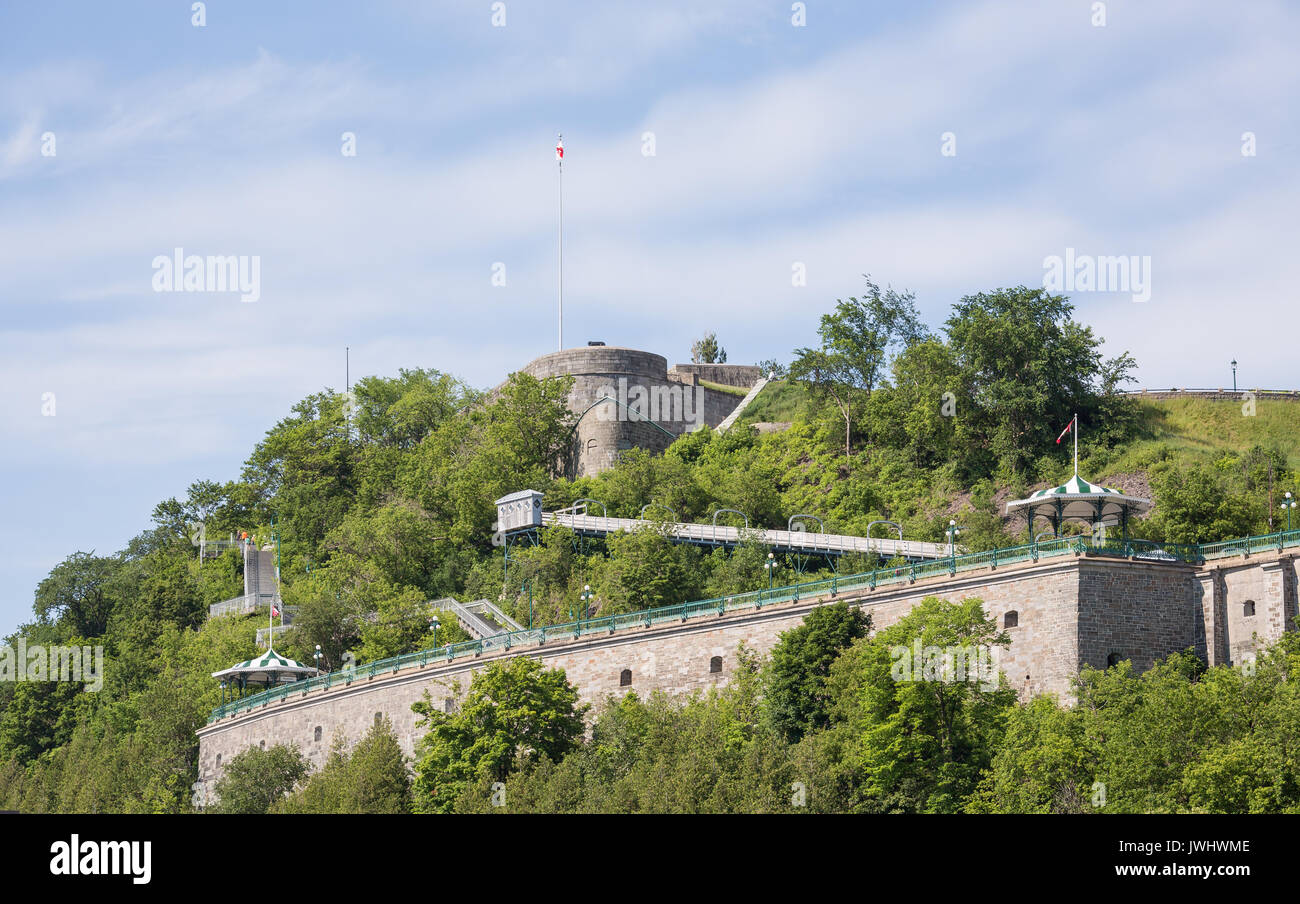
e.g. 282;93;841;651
412;656;586;813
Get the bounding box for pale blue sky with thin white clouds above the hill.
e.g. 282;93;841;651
0;0;1300;633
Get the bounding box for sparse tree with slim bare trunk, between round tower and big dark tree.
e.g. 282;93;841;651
790;276;924;458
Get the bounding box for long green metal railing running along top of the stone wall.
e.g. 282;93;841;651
209;529;1300;722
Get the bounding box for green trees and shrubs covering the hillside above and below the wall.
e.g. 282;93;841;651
0;281;1300;812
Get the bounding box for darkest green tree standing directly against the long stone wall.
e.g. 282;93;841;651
767;602;871;743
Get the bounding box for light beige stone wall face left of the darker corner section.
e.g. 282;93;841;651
199;559;1078;787
